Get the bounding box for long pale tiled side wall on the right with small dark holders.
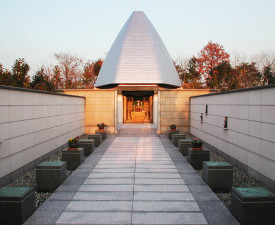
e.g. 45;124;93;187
191;85;275;191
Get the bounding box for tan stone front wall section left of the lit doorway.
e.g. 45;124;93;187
64;89;117;134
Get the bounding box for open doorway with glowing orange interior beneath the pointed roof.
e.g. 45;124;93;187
122;91;154;123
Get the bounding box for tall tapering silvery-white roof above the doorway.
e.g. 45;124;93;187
95;11;181;87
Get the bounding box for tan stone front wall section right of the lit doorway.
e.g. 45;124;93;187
159;89;216;133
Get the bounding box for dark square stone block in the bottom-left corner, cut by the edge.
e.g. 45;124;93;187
0;187;35;225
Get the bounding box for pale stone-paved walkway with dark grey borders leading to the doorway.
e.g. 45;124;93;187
25;125;238;225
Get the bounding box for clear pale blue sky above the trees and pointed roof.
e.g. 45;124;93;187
0;0;275;75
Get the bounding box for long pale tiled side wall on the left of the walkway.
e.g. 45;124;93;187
0;86;85;185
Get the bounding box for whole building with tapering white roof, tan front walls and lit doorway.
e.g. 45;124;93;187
64;11;215;133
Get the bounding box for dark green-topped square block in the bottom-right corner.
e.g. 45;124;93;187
231;187;275;225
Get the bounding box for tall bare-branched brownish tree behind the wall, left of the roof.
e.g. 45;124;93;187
54;53;83;88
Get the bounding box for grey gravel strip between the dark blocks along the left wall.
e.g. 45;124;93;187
7;152;73;208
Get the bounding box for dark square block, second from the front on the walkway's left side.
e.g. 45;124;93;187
35;161;67;192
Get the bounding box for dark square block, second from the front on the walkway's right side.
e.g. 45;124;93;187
202;161;233;192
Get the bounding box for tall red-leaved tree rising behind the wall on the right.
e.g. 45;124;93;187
196;41;230;86
